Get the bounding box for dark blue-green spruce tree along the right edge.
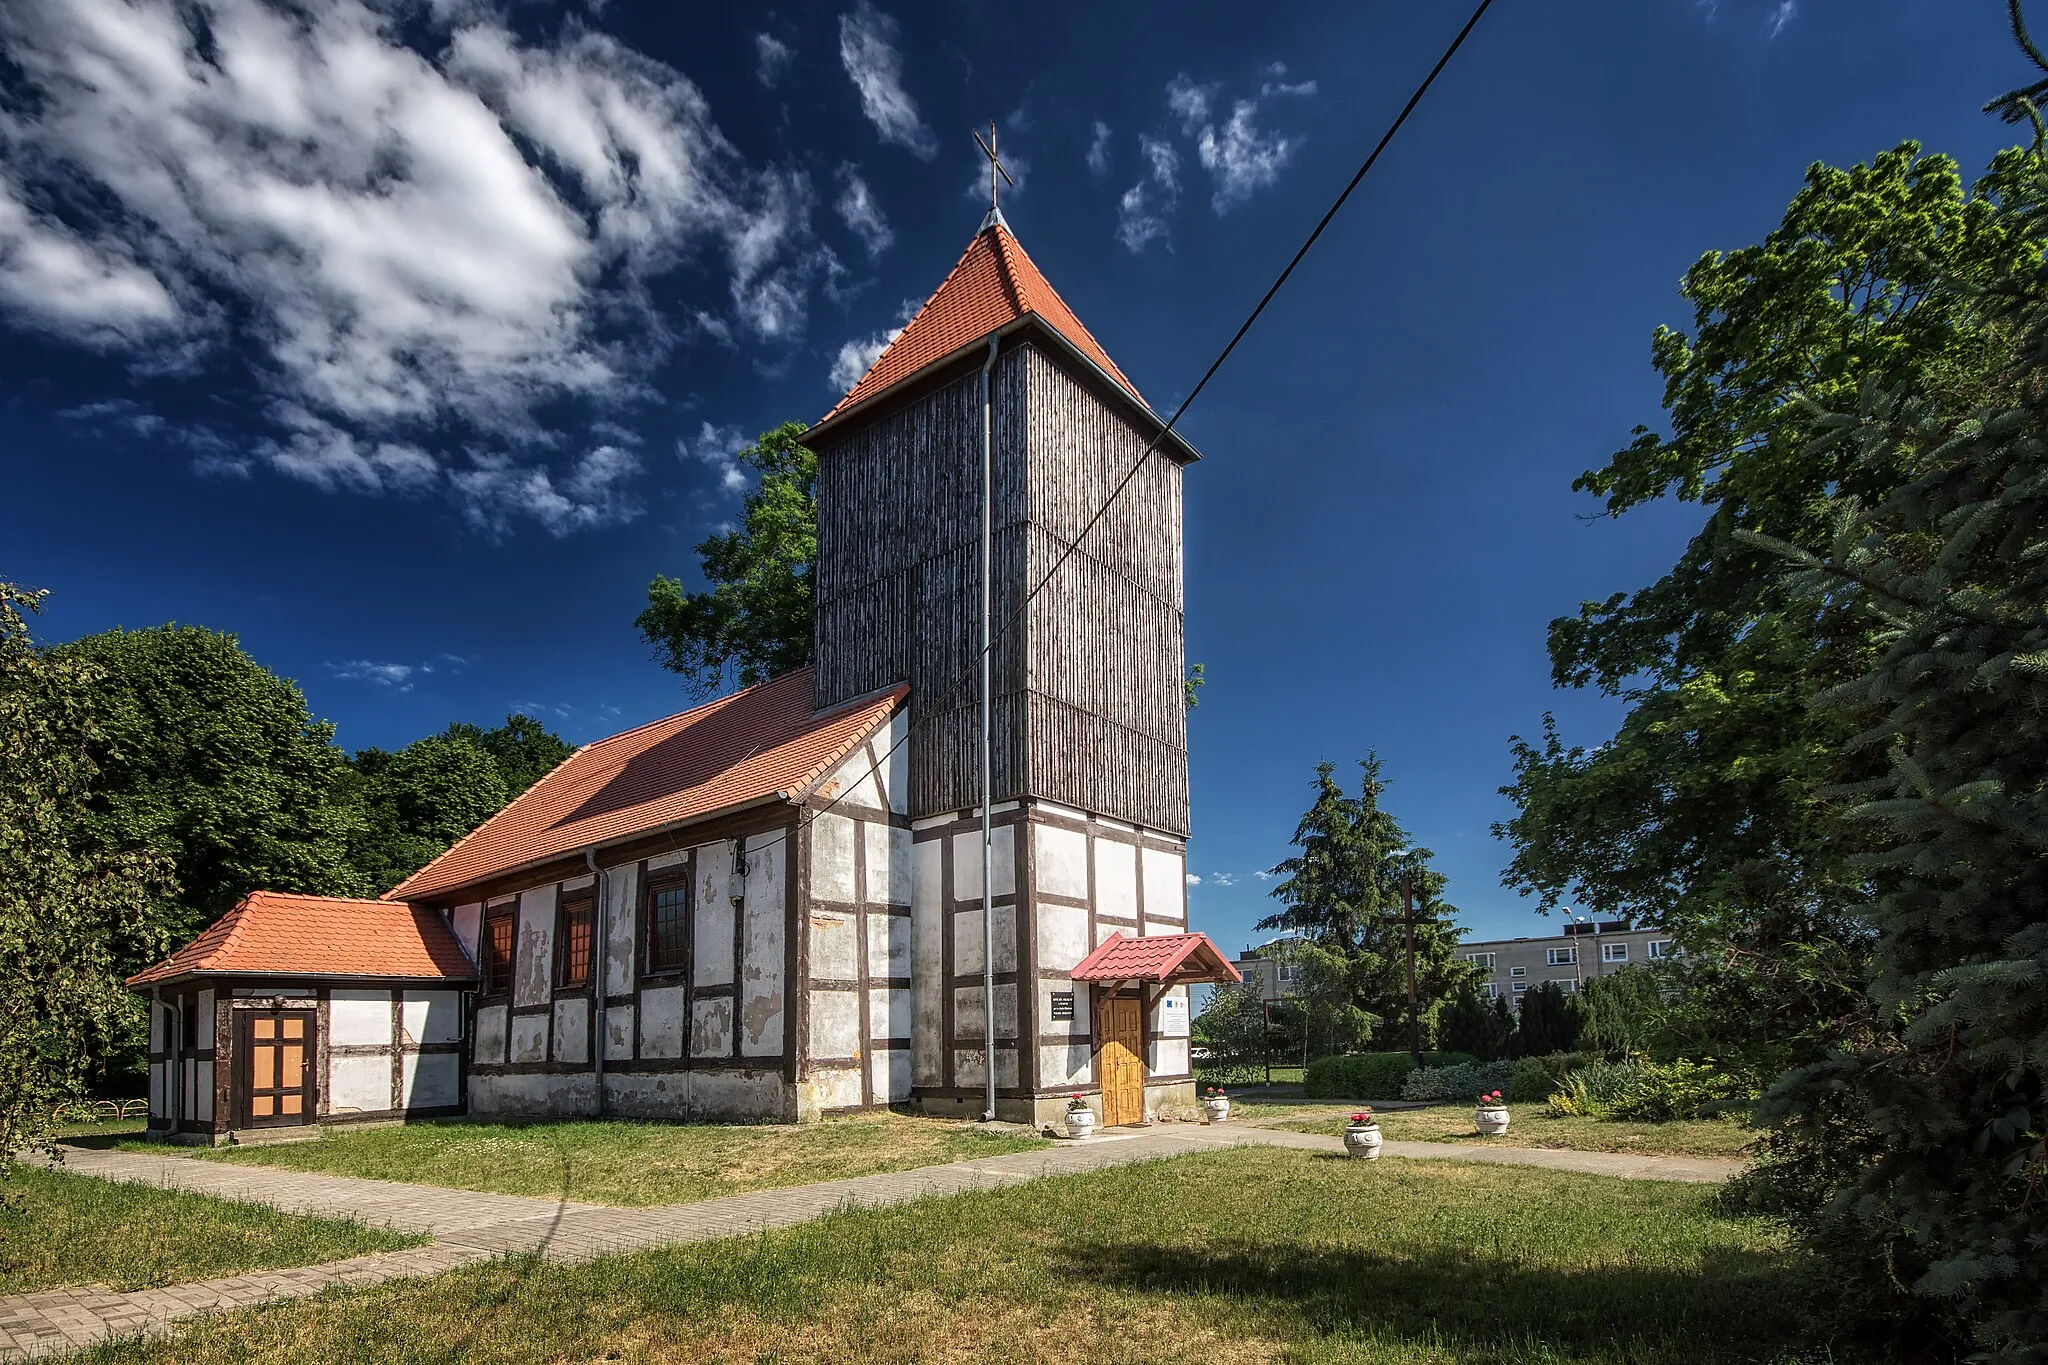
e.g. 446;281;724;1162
1751;63;2048;1363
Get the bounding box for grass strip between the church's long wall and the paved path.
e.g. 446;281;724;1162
123;1113;1047;1203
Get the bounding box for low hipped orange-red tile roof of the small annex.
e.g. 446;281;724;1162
127;890;477;986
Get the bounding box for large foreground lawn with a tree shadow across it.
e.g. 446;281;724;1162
86;1148;1808;1365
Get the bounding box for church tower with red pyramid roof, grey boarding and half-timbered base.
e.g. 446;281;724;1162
805;209;1196;1124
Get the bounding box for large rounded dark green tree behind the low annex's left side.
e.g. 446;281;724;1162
49;626;369;929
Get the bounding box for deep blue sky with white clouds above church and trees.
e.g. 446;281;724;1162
0;0;2025;952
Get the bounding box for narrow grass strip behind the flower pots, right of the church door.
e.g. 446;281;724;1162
1233;1101;1757;1158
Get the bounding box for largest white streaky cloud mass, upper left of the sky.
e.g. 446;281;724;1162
0;0;836;528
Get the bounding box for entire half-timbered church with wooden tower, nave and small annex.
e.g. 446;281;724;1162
129;209;1237;1144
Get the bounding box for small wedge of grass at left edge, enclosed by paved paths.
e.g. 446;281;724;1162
0;1169;426;1293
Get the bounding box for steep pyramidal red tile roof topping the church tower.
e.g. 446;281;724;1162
821;223;1151;422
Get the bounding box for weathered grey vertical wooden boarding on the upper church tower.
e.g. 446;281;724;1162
815;342;1188;837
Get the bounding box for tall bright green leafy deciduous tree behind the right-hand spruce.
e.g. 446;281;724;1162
1499;143;2042;1064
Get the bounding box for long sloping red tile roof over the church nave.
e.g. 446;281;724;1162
385;669;909;900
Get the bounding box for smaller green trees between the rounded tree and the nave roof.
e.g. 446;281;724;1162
348;716;573;894
